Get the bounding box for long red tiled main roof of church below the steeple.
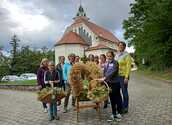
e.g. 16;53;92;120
71;17;119;44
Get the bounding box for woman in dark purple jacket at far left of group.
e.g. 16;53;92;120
37;58;48;113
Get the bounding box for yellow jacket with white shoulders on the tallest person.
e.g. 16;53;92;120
115;52;132;78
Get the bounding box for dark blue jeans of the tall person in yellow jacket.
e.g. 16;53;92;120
119;76;129;109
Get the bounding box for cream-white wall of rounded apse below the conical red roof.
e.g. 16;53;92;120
55;44;84;64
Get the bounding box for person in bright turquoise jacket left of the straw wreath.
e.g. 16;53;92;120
63;53;75;113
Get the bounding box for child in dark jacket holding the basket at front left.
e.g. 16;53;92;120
44;62;60;121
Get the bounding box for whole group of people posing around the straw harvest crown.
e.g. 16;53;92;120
37;42;131;121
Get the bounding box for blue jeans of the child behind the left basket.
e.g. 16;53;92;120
48;101;57;120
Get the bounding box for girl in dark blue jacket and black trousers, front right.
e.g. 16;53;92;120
104;51;122;121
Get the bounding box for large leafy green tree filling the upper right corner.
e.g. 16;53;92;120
123;0;172;70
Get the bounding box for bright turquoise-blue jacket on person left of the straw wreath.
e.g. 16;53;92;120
63;63;72;81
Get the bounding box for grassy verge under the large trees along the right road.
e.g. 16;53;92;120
136;69;172;81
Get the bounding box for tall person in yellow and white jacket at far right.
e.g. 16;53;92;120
115;42;132;113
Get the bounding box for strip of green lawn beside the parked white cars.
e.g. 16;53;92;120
0;80;37;85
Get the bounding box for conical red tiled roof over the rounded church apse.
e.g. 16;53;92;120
55;31;88;46
